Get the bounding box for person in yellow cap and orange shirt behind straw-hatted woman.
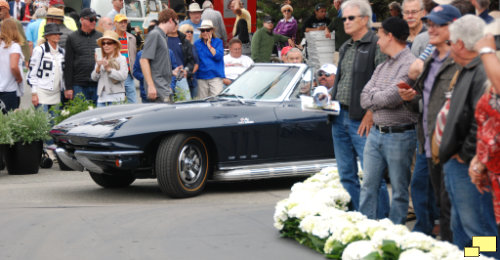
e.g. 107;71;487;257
114;14;137;103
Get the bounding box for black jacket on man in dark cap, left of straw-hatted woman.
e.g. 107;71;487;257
64;29;102;90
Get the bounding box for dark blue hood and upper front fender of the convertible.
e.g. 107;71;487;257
51;100;274;138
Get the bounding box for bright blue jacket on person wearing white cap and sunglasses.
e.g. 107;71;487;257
194;38;226;79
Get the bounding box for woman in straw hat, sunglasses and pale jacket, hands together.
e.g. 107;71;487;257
91;31;128;107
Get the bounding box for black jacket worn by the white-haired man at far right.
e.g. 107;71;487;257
439;56;487;163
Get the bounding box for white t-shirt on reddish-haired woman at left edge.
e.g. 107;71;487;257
0;41;24;96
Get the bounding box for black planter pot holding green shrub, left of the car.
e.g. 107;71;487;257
4;141;43;174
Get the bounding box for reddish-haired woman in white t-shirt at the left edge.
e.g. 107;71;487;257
0;18;24;111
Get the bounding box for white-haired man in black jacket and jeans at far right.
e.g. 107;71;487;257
436;14;500;259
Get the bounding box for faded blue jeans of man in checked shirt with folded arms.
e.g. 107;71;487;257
359;127;417;224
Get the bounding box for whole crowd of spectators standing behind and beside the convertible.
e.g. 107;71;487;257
0;0;500;254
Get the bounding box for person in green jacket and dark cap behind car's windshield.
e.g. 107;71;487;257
252;15;295;62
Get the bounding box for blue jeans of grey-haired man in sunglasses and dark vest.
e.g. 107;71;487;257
332;110;389;219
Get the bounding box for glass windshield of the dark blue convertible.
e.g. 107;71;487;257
220;66;299;100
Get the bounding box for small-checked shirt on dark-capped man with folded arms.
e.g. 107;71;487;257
361;47;418;126
